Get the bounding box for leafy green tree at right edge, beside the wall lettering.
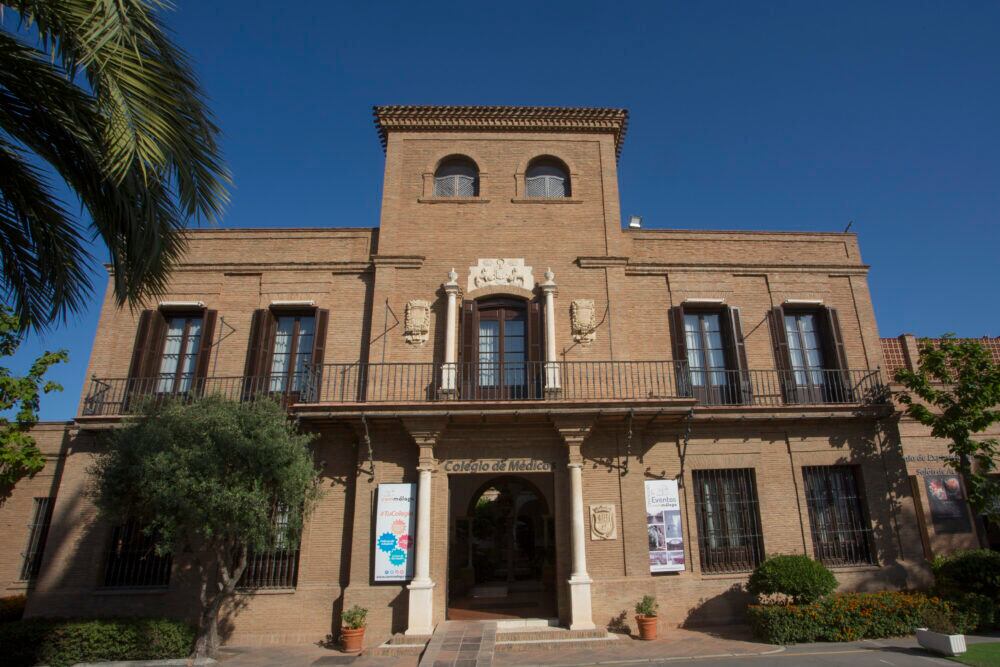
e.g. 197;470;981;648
896;334;1000;537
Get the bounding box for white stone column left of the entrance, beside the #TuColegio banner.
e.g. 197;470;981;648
404;419;444;635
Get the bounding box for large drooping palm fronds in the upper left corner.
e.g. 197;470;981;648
0;0;230;329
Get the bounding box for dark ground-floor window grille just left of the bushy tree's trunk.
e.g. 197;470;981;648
104;520;172;588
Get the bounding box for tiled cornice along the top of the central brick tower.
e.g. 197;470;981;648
373;105;628;156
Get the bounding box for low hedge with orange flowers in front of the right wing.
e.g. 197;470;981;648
747;591;963;644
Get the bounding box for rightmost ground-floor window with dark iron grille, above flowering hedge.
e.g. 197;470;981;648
802;466;874;565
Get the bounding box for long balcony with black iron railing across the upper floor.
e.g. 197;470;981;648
82;361;887;417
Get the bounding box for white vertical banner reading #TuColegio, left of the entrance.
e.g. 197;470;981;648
373;484;417;581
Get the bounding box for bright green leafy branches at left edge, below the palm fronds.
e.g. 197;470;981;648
0;306;69;491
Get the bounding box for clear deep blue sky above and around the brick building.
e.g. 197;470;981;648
9;0;1000;419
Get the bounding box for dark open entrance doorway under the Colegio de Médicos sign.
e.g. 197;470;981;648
448;473;557;620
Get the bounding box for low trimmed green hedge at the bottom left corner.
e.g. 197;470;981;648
0;618;195;667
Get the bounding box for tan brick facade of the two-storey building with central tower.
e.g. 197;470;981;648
0;107;975;643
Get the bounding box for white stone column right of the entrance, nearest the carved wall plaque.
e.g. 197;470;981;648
556;420;595;630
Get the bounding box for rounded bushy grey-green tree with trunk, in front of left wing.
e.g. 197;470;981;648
91;396;319;657
